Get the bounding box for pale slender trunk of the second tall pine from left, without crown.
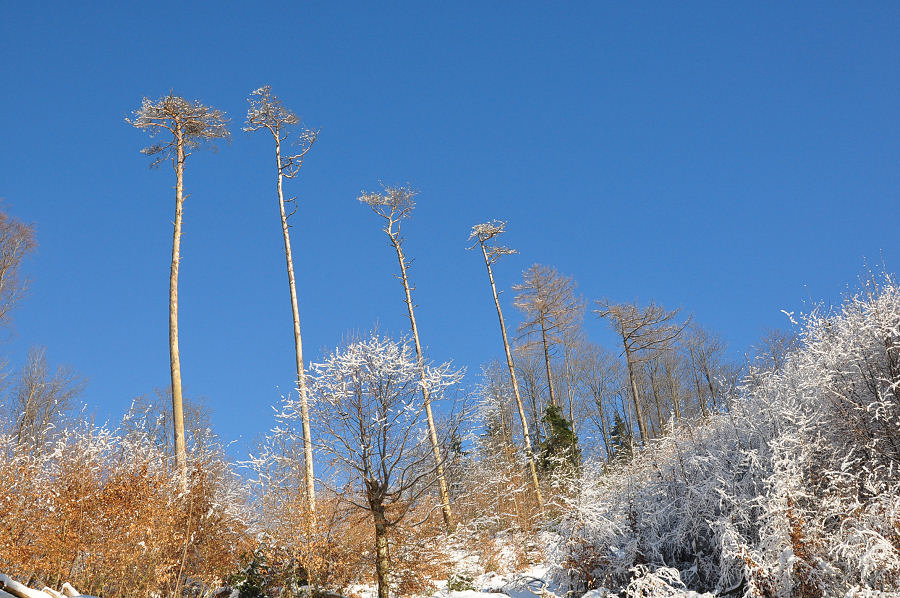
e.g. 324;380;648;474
273;138;316;529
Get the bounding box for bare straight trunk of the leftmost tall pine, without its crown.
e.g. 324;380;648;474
169;117;187;488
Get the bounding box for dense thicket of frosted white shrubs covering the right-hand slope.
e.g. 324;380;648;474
550;281;900;597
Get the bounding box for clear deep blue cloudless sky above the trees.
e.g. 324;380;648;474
0;1;900;452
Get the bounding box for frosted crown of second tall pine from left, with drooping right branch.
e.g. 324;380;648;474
243;85;319;178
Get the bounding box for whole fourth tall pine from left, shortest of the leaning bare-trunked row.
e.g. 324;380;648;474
469;220;544;506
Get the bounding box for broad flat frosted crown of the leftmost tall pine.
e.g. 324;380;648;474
125;93;230;166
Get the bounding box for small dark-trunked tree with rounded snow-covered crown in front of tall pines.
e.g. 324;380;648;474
298;334;462;598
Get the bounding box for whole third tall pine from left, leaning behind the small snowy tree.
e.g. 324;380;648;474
359;187;454;530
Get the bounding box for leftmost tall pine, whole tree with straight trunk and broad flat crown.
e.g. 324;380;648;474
126;93;229;483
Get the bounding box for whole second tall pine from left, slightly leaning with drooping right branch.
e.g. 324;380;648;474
244;85;319;526
